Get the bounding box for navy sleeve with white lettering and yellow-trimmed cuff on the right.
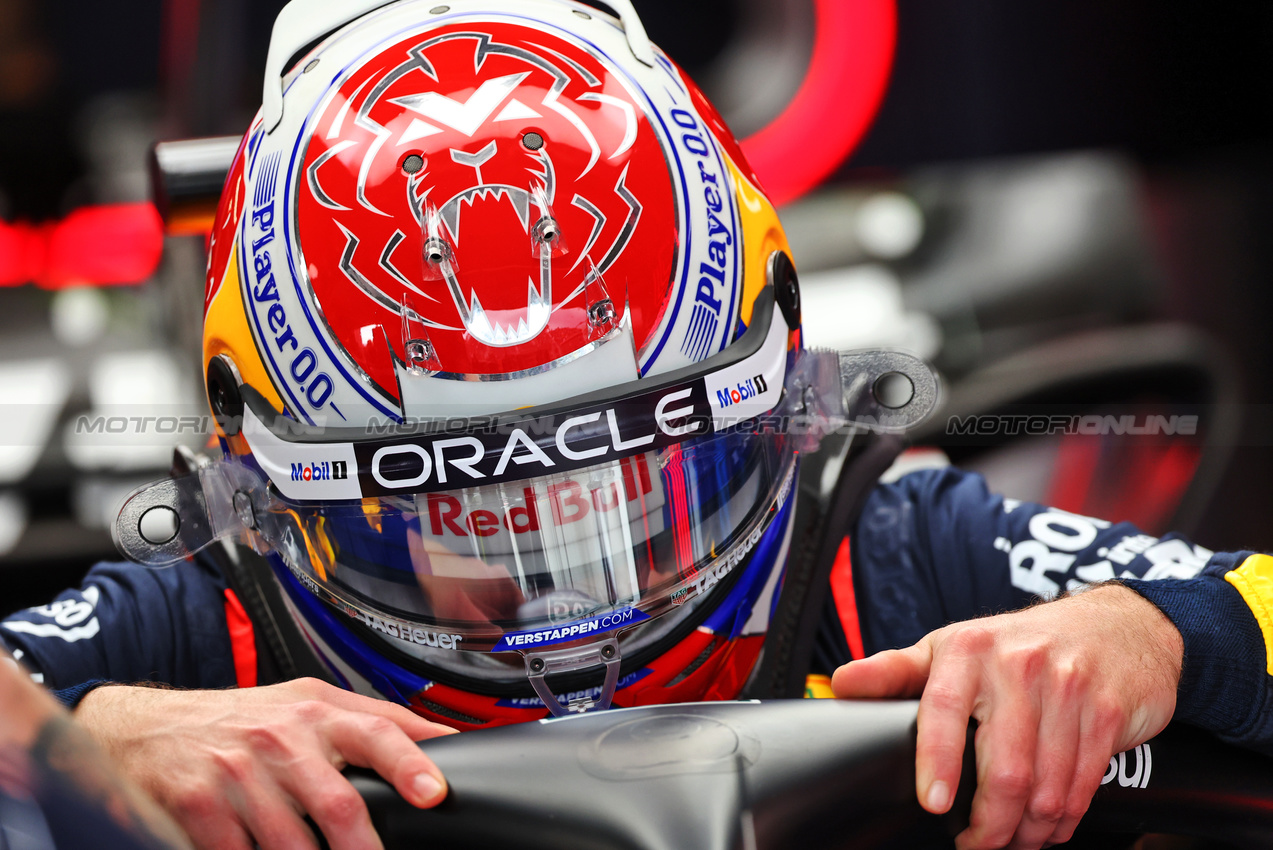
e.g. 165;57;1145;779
852;468;1273;755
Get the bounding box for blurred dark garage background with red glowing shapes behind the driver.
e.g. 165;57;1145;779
0;0;1273;613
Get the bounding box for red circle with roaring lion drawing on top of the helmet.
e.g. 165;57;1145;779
297;24;677;397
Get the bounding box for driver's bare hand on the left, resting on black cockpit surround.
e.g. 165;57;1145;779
75;679;454;850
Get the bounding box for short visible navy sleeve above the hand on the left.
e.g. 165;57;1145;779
0;560;236;691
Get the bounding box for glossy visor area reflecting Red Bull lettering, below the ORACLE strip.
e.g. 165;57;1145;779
267;433;794;649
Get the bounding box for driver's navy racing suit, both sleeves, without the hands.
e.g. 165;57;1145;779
0;468;1273;752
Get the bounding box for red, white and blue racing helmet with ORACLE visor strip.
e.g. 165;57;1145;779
116;0;926;728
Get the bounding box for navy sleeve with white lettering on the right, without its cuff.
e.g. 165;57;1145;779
852;467;1212;653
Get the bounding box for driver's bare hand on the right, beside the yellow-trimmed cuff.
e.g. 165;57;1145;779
831;585;1184;850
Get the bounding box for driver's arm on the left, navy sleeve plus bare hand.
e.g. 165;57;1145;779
0;561;449;849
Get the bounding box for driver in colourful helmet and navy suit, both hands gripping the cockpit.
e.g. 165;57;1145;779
0;0;1267;847
